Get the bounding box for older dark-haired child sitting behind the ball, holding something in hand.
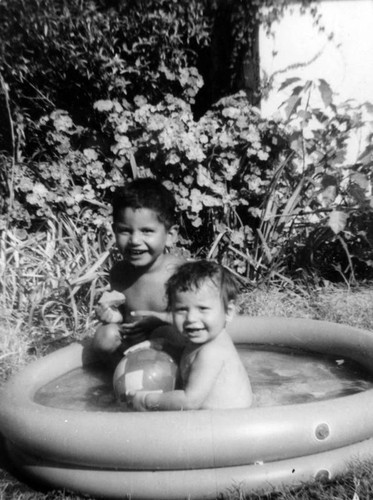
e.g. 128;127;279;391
93;178;182;361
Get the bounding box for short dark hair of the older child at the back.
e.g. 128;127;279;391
112;177;176;229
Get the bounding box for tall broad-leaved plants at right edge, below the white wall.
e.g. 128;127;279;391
282;78;373;283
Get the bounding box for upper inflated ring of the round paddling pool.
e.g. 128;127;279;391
0;316;373;498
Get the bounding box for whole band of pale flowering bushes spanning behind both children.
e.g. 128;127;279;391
1;76;373;281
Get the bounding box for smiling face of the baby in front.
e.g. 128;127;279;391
172;280;234;344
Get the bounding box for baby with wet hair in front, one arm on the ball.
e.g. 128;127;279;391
132;260;252;411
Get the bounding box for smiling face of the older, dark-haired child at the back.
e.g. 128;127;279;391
113;207;174;267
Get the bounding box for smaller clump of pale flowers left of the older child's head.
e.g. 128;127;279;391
0;110;123;237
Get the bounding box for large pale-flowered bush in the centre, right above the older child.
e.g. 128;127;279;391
95;92;291;268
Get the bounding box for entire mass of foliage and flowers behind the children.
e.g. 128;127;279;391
0;0;373;282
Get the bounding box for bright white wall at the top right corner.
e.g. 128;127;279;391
259;0;373;162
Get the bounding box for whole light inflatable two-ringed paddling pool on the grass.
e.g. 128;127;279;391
0;317;373;500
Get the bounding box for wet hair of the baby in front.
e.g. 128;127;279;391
166;260;239;311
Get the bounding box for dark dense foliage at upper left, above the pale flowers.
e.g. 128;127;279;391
0;0;209;150
